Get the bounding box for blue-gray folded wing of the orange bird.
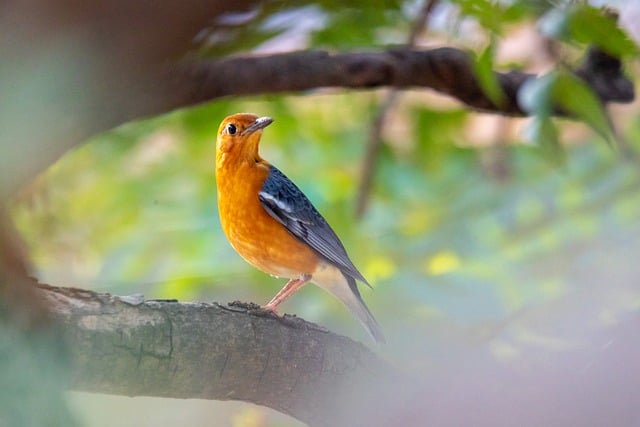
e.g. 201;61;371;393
258;165;369;285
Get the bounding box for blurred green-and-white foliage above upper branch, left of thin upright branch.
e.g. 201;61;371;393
198;0;413;56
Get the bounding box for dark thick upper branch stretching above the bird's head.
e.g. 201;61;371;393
168;48;634;116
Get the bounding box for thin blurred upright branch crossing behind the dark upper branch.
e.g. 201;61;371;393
356;0;437;218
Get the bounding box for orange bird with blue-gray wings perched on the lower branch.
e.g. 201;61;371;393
215;113;385;343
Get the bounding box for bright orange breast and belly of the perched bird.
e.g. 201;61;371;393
216;162;318;278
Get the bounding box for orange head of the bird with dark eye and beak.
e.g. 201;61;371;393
216;113;273;165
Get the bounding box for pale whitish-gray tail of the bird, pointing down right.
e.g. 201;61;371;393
314;267;385;343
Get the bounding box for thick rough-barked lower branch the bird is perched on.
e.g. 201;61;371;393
41;285;392;426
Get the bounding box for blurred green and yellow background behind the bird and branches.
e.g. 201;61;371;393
6;0;640;426
